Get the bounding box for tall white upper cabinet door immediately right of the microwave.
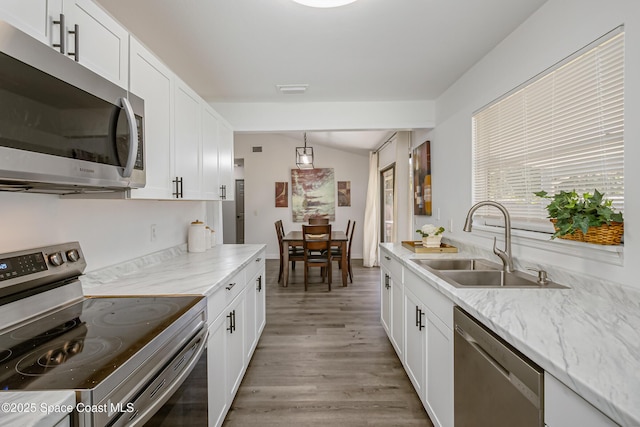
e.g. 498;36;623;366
129;37;174;199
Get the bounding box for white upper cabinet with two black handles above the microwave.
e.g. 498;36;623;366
0;0;129;88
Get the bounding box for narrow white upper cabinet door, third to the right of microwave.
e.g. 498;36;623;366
201;105;220;200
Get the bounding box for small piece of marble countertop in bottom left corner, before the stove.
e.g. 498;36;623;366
0;390;76;427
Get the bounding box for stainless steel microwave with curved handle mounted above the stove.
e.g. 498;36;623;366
0;21;145;194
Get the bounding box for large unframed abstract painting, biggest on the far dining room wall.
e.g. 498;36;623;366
291;168;336;222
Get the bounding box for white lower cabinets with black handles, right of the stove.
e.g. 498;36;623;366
207;250;265;426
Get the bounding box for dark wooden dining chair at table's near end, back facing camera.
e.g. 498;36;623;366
302;224;332;291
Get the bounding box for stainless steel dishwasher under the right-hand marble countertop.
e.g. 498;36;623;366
453;307;544;427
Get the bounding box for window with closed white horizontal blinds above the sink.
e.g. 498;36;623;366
472;28;624;231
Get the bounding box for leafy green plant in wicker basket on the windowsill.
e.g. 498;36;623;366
534;190;624;245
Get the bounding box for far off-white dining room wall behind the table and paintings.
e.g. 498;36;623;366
234;133;369;258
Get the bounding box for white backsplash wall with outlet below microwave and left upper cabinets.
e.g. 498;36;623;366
0;192;205;271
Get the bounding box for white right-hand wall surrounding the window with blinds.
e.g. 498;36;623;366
420;0;640;287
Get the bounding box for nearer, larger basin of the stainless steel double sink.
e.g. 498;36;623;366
439;270;567;289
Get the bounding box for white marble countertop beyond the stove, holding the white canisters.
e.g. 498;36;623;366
80;245;266;295
